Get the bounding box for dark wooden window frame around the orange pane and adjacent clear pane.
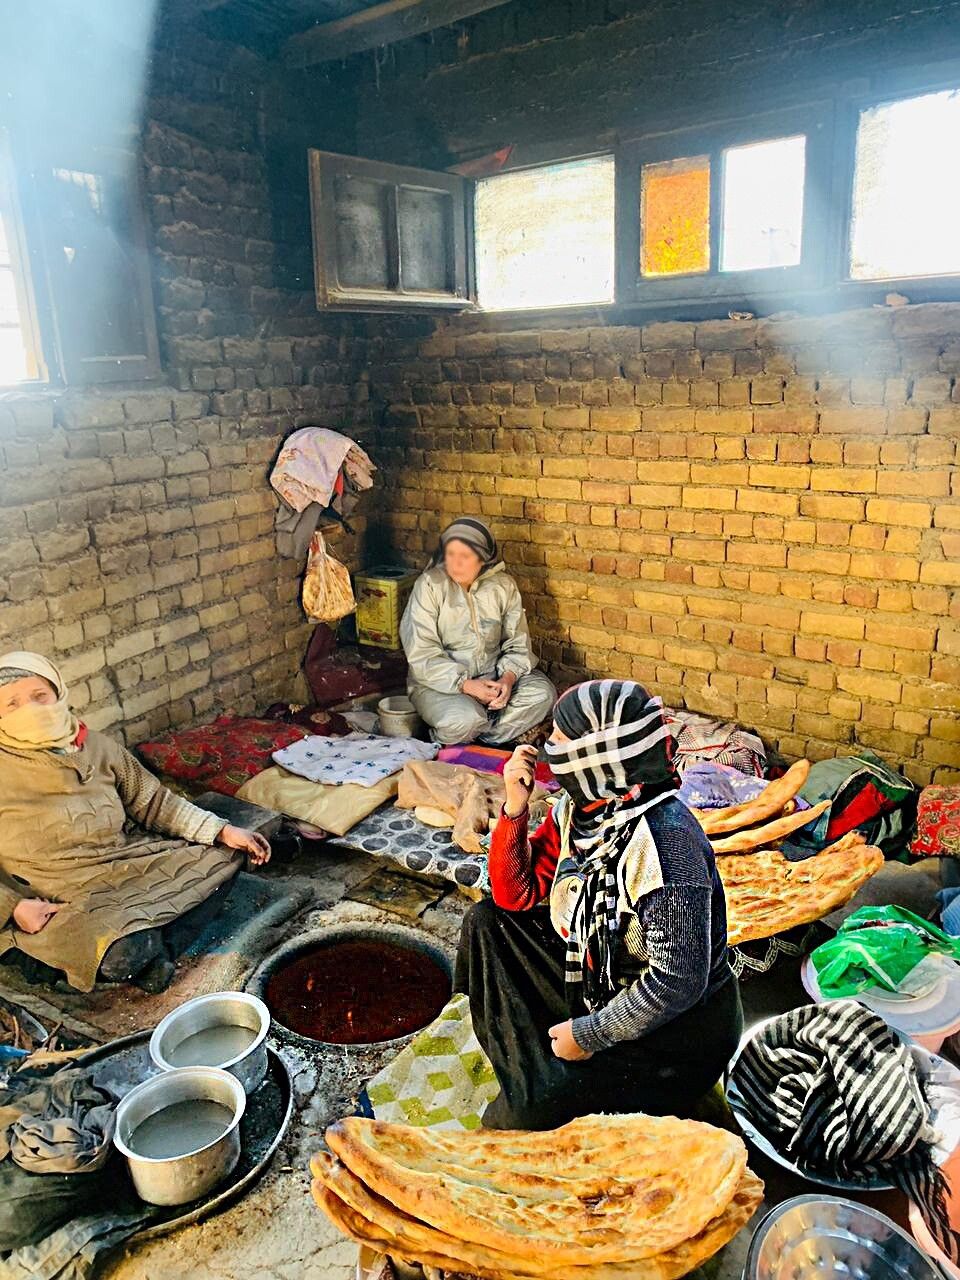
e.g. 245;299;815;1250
617;101;833;306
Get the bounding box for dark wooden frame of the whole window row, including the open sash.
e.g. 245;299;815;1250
311;58;960;320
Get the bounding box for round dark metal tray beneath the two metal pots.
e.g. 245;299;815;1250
73;1032;293;1243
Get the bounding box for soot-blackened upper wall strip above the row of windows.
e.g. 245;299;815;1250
342;0;960;168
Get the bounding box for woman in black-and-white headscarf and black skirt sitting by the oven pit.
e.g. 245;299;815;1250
454;680;742;1129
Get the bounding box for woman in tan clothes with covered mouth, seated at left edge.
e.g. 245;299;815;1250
0;653;270;991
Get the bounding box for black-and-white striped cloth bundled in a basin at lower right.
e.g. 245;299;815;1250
731;1000;960;1262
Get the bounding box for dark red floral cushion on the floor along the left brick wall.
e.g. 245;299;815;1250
137;716;310;796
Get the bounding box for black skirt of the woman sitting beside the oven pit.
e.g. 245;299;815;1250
453;900;742;1129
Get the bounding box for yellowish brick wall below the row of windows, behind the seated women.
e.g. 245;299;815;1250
371;306;960;783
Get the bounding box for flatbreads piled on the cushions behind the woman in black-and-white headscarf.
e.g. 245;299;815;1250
694;760;883;946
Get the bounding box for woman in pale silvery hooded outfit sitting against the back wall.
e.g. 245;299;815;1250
401;516;557;744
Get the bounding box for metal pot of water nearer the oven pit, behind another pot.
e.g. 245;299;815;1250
150;991;270;1093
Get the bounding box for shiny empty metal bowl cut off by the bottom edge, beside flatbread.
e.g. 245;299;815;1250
744;1196;942;1280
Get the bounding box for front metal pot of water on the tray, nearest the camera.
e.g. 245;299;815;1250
114;1066;247;1204
